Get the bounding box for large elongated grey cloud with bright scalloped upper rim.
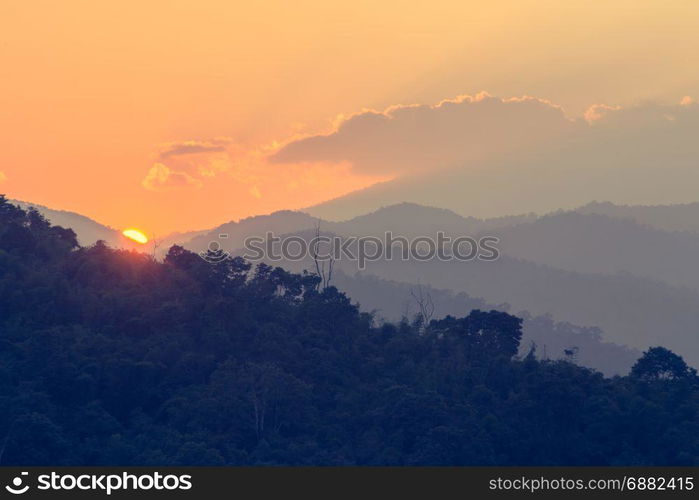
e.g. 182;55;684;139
271;93;580;174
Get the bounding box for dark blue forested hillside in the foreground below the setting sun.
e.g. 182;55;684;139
0;197;699;465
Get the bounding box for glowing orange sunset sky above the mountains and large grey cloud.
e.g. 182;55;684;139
0;0;699;235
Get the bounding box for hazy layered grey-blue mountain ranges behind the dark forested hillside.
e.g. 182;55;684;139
20;198;699;373
